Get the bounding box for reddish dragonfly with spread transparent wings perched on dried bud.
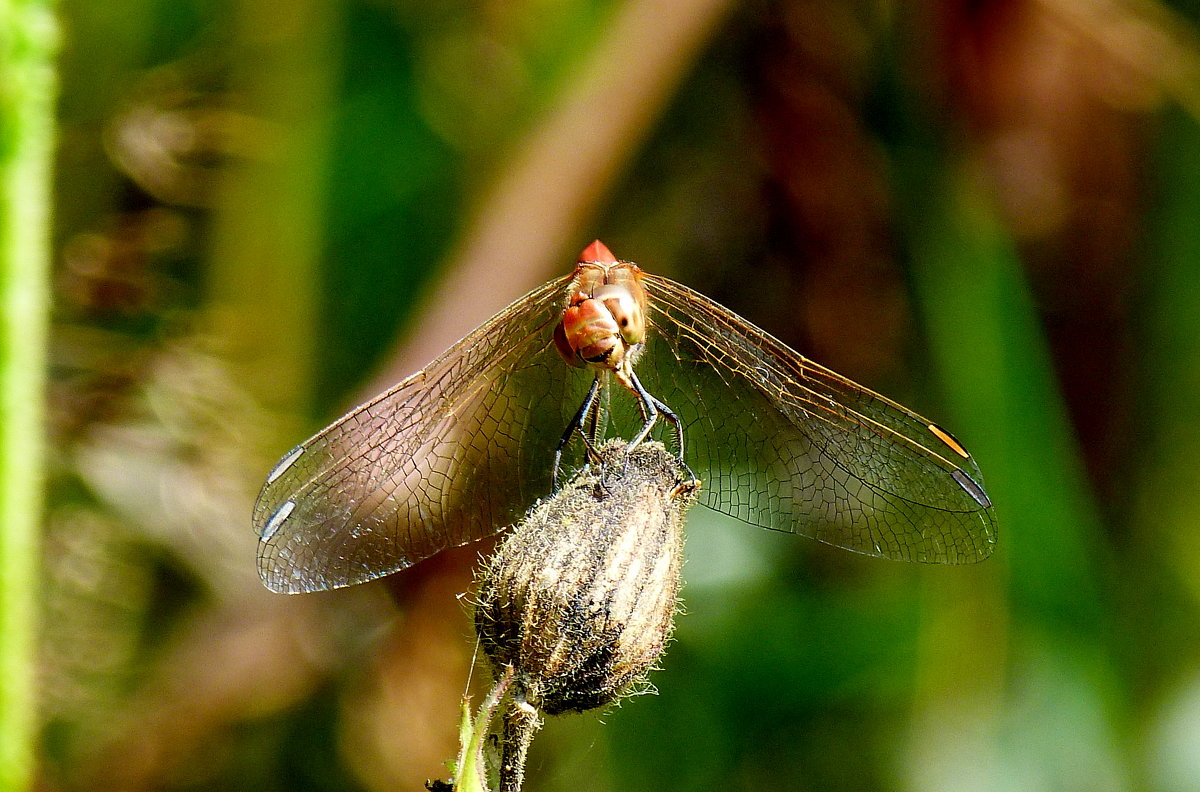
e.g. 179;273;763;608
253;240;996;593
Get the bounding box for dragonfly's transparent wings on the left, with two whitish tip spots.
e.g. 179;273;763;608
253;277;594;592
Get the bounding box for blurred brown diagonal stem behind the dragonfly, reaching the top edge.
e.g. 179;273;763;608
365;0;731;395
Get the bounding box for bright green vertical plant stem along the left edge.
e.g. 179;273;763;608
0;0;56;792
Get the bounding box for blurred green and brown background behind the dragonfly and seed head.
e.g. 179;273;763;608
40;0;1200;792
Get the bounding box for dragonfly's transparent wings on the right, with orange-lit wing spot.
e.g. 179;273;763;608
633;275;996;564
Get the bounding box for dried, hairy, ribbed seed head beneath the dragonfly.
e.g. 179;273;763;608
475;440;700;715
